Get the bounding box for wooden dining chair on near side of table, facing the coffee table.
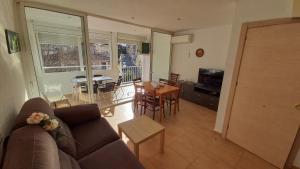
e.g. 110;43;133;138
144;90;165;120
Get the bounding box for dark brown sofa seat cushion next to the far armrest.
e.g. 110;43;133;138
71;118;119;159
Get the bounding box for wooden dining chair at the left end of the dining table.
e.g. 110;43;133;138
133;82;145;114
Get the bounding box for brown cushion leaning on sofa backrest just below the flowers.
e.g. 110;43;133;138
56;118;77;157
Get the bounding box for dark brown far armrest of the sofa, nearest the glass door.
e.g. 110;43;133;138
54;104;101;127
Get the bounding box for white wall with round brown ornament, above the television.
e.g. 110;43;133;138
171;25;231;82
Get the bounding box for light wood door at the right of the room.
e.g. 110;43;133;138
227;21;300;168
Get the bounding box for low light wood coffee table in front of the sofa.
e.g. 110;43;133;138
118;116;165;159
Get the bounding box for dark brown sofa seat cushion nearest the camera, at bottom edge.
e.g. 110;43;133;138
79;140;144;169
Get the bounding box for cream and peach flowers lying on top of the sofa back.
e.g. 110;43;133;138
26;112;59;131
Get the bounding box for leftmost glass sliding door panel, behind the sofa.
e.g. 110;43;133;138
25;7;91;107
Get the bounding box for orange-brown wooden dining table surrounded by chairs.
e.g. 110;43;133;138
136;81;180;122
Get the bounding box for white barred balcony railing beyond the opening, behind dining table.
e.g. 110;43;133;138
122;66;143;83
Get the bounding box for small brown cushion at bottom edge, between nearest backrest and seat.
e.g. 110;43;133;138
58;150;80;169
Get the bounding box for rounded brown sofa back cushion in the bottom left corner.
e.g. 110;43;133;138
3;125;60;169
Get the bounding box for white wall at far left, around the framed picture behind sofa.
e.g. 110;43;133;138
0;0;26;137
